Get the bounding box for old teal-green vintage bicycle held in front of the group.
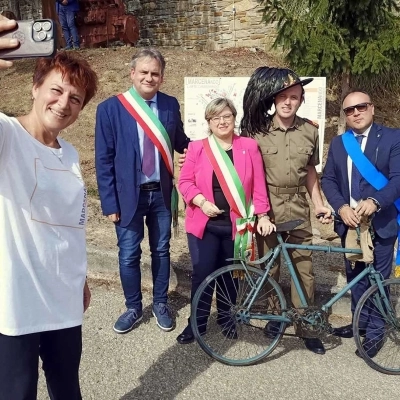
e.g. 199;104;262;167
191;216;400;375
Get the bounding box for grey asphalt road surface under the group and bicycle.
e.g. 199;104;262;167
39;286;400;400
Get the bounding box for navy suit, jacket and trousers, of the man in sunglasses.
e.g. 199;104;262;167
321;124;400;336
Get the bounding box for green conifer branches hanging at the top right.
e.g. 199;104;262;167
260;0;400;76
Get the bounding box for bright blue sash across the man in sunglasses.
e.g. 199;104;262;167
342;131;400;266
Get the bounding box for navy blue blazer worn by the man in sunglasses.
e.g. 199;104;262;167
321;124;400;239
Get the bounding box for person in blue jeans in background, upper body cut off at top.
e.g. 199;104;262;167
56;0;80;50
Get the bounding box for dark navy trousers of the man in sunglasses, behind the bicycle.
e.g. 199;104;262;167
342;234;396;339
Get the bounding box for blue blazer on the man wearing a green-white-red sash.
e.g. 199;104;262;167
95;92;190;227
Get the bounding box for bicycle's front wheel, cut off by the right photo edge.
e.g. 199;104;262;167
353;279;400;375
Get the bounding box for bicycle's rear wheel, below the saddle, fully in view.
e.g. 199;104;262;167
191;265;286;365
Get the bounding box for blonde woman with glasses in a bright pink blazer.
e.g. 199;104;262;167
177;98;275;344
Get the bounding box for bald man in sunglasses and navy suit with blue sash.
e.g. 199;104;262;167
322;90;400;358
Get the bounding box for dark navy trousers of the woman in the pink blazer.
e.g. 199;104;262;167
187;223;236;332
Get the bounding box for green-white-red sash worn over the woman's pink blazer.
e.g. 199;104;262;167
203;135;256;260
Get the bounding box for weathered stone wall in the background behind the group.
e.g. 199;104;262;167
0;0;275;50
